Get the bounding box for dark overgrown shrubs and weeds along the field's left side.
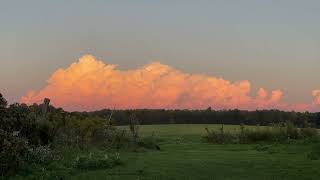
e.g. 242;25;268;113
0;94;159;179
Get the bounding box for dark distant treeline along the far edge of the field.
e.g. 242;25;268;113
84;108;320;127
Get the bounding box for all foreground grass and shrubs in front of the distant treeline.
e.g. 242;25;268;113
0;93;320;180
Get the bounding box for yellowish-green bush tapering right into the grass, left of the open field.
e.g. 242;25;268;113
54;116;159;150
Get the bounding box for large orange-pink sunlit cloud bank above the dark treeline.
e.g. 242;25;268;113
21;55;320;111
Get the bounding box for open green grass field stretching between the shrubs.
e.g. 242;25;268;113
7;125;320;180
